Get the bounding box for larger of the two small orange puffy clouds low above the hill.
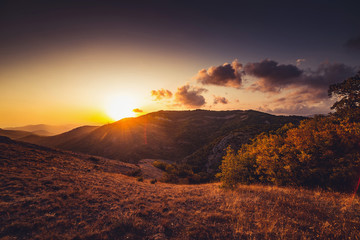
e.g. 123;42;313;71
175;84;207;108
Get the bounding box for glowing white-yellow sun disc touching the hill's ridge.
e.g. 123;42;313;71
105;95;136;121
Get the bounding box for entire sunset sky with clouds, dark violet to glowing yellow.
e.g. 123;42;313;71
0;0;360;127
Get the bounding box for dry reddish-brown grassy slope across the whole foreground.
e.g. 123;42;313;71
0;136;360;240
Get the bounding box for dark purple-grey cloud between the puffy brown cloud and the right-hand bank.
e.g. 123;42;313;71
244;60;303;92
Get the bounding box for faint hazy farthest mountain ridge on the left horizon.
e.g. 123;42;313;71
4;124;76;136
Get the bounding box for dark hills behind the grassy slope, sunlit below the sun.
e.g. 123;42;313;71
0;110;304;172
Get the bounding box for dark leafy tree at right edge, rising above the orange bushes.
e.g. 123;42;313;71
328;72;360;122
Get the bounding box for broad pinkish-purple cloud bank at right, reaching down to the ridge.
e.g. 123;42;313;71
250;62;356;115
